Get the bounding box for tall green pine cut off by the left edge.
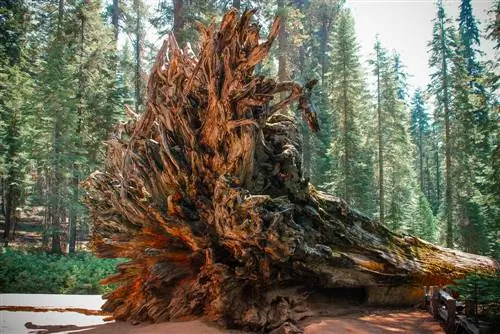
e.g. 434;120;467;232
0;0;33;245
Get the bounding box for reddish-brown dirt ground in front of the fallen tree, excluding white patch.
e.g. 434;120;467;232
16;310;444;334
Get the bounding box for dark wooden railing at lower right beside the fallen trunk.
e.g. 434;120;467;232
425;286;481;334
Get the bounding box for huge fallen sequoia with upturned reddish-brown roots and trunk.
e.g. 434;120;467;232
84;10;496;333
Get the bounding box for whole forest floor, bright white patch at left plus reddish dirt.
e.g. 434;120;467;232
0;294;444;334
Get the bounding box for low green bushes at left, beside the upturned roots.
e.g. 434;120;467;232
0;248;124;294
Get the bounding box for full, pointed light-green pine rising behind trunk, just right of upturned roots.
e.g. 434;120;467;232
329;10;375;215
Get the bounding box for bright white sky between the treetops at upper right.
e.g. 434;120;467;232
346;0;494;89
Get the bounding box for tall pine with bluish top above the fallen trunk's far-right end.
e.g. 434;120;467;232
452;0;497;253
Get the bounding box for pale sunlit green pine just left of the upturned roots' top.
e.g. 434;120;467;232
67;1;121;253
